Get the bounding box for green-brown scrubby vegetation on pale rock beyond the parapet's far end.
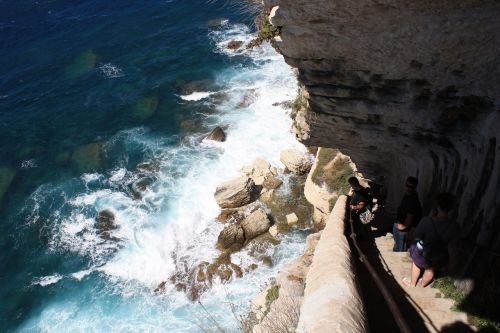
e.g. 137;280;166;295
311;148;354;194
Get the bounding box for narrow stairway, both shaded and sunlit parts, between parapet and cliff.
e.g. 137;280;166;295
346;206;472;332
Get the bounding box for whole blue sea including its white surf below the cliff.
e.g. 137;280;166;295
0;0;304;332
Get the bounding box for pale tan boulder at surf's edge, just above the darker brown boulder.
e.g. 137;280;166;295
214;177;256;208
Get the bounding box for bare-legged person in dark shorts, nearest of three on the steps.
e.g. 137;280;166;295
402;193;458;287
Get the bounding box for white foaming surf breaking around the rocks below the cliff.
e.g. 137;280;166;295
21;24;305;332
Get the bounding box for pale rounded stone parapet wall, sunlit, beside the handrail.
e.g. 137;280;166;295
296;196;367;333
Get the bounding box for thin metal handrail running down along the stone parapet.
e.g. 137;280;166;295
347;206;411;333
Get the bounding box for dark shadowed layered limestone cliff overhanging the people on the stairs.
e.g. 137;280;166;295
264;0;500;251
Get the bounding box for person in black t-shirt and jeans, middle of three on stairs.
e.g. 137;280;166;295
392;177;422;252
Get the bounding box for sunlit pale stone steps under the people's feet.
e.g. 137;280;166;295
376;234;475;332
